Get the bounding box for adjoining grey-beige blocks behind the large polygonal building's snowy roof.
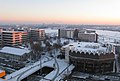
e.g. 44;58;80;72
58;29;98;42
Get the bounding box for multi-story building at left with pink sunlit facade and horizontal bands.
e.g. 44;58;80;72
2;31;28;46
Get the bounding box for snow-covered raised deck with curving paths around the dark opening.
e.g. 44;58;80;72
0;55;74;81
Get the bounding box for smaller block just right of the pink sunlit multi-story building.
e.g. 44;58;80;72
29;29;45;41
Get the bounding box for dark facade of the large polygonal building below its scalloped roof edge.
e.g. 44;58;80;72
69;51;114;73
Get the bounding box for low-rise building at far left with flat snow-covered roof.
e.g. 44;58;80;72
0;47;31;61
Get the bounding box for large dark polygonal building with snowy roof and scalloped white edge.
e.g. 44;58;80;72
62;42;115;73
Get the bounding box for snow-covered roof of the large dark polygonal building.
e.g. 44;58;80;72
63;42;107;54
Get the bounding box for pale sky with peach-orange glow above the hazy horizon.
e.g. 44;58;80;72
0;0;120;25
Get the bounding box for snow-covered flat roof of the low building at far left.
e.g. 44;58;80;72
0;47;30;56
